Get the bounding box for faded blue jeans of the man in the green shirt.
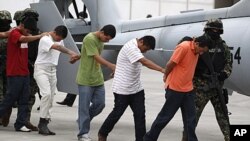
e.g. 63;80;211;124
77;85;105;137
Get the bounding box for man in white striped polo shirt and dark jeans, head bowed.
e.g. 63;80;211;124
98;36;165;141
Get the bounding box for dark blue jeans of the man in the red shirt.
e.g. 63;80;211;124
0;76;30;130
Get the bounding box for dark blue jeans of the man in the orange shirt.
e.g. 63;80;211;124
143;89;198;141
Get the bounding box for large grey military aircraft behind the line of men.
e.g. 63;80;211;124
28;0;250;96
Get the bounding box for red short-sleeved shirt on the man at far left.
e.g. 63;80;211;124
6;28;29;76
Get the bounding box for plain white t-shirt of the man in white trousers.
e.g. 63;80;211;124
35;36;64;66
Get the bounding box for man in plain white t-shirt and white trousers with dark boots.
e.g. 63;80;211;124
34;25;80;135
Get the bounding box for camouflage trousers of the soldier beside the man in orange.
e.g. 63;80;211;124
195;89;230;141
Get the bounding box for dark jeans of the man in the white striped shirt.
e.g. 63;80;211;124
99;90;146;141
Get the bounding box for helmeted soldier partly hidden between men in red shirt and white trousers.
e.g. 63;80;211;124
13;8;39;131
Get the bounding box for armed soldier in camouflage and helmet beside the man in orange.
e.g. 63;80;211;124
182;19;232;141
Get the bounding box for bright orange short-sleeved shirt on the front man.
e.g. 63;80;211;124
165;41;199;92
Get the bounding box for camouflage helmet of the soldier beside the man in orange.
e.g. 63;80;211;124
204;19;223;34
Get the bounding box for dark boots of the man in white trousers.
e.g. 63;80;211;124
38;118;56;135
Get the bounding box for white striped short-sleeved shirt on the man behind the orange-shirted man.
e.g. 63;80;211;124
112;39;144;95
